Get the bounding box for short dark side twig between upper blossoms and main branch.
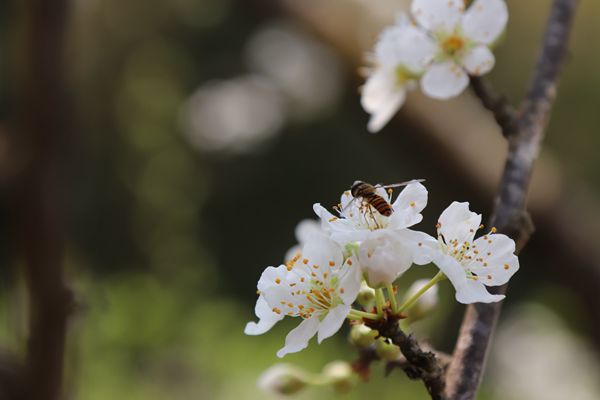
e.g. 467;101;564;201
471;76;517;138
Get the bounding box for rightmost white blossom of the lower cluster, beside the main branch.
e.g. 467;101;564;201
421;202;519;304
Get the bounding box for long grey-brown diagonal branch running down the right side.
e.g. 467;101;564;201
446;0;578;400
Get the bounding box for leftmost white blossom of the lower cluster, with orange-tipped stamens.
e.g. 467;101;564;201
245;237;361;357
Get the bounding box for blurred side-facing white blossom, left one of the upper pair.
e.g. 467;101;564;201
361;15;436;132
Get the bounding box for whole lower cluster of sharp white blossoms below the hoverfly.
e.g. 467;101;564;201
245;181;519;357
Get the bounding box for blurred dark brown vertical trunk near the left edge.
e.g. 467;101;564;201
11;0;72;400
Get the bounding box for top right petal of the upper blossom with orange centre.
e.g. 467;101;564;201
462;0;508;44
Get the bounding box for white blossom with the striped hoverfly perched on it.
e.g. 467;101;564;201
313;182;427;287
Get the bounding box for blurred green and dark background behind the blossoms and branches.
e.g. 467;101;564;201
0;0;600;400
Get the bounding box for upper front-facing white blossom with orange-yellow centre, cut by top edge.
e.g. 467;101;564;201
411;0;508;99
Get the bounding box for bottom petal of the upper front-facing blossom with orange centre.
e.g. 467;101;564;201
421;61;469;100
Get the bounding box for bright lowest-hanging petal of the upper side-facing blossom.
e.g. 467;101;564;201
361;68;406;133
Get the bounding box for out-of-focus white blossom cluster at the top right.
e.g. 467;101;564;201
361;0;508;132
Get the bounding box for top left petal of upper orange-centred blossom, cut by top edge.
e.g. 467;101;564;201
411;0;465;33
